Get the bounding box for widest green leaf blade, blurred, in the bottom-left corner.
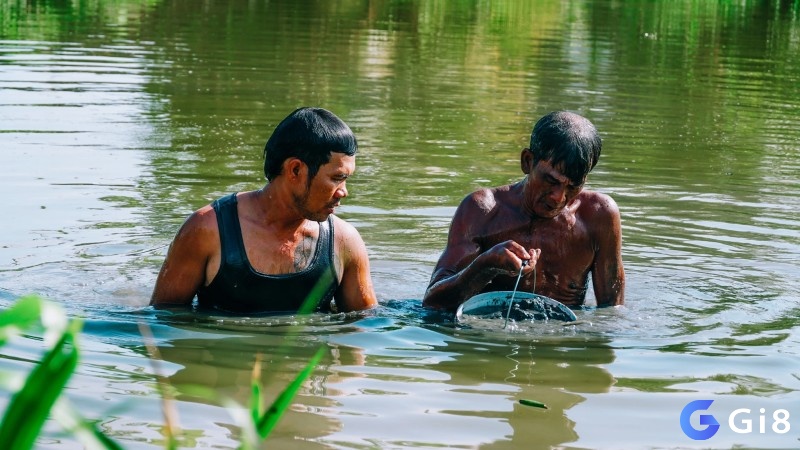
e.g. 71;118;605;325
0;329;78;450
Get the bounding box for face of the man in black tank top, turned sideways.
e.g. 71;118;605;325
295;152;356;222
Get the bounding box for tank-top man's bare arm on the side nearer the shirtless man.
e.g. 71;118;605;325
334;218;378;311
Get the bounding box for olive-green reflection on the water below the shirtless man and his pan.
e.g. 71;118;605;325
428;336;614;448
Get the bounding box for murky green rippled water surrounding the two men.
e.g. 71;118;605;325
0;0;800;449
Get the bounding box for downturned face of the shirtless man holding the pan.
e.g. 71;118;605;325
528;161;583;218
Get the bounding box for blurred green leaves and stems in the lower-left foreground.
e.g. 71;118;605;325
0;296;324;450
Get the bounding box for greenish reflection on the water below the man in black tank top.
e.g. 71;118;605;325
159;333;344;445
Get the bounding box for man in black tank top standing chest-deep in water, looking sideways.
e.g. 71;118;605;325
150;108;377;314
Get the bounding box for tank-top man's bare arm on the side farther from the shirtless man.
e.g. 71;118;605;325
150;208;219;306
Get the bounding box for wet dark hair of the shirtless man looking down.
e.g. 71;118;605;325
529;111;603;184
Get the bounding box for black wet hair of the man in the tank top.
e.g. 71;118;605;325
264;107;358;184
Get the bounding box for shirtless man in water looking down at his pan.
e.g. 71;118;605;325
423;111;625;310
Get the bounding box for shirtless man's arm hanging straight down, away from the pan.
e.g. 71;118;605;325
590;194;625;306
